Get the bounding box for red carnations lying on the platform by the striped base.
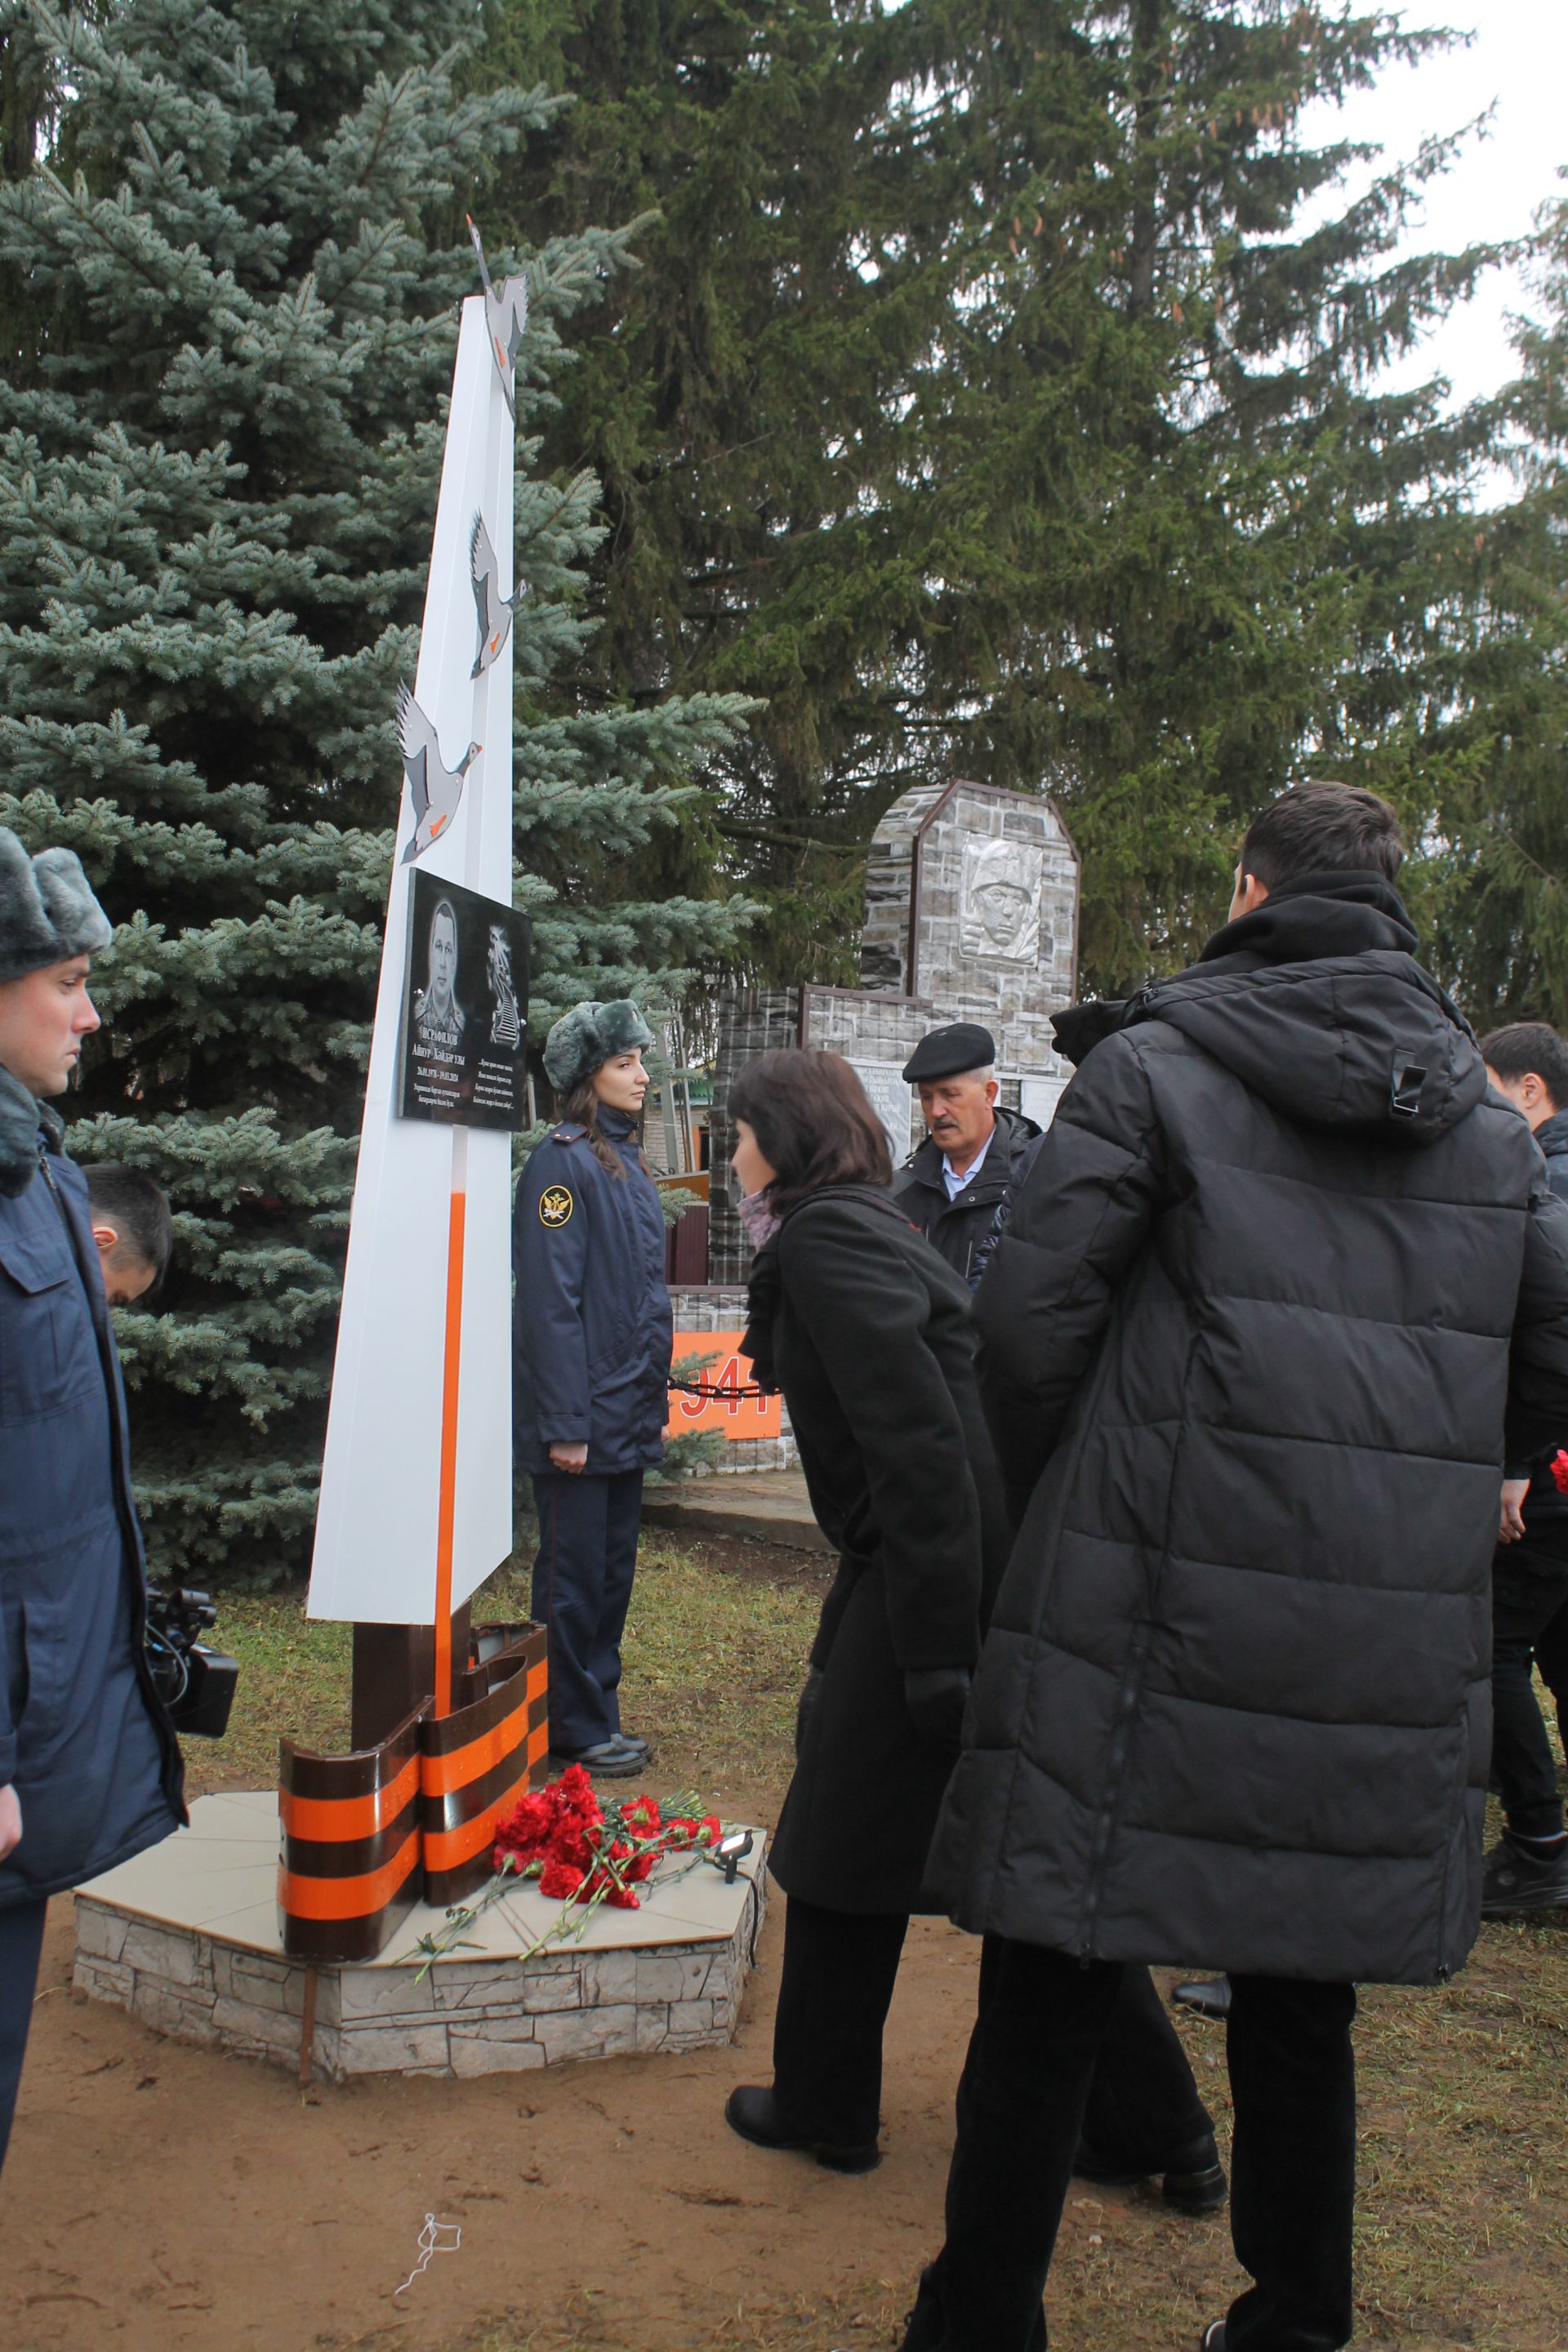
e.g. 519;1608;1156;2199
496;1764;722;1910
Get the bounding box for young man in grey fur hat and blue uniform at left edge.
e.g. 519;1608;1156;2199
0;826;185;2162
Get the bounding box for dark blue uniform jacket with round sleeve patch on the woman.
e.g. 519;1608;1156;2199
513;1110;672;1477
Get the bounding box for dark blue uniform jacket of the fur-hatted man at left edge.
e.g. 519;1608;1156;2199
0;1072;185;1910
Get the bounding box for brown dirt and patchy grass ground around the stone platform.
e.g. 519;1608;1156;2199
0;1545;1568;2352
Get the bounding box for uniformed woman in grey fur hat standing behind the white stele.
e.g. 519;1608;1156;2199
513;997;672;1778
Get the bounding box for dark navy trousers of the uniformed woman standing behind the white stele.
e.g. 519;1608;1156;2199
533;1470;642;1754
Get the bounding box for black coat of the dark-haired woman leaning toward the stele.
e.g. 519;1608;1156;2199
746;1186;1009;1912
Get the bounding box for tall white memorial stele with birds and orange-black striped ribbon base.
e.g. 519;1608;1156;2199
278;235;548;1962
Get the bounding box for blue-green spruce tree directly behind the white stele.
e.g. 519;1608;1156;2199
0;0;746;1580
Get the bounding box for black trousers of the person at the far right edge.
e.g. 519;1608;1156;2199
1493;1521;1568;1837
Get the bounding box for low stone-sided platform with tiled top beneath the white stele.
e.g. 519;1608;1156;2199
75;1790;766;2082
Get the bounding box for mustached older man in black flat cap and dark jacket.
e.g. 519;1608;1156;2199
893;1021;1041;1284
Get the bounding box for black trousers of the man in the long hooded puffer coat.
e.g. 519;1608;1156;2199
905;1936;1356;2352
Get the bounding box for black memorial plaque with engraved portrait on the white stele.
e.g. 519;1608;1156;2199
397;868;529;1127
